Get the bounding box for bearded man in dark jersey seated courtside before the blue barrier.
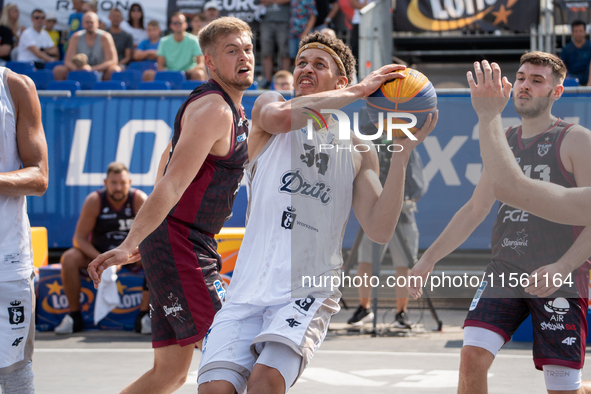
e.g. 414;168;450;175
55;162;148;334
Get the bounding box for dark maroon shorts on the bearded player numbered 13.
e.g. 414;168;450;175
464;262;588;370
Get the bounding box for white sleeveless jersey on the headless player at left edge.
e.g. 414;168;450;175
0;67;33;282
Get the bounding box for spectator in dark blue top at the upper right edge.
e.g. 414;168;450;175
560;20;591;86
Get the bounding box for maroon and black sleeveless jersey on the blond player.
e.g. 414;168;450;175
165;80;248;236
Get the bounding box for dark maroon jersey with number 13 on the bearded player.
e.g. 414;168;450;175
491;119;589;273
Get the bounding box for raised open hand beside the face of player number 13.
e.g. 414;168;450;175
466;60;512;117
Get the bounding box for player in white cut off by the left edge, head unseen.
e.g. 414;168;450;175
0;67;48;394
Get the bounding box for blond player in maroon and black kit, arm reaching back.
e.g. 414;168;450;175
88;18;254;393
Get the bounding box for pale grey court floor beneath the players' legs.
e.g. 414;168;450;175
33;310;591;394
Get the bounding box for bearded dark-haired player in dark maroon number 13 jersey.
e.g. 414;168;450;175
410;52;591;394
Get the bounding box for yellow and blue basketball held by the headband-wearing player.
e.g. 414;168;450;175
367;67;437;138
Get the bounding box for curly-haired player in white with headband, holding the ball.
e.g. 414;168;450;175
198;33;437;394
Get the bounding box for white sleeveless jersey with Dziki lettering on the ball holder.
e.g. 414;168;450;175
226;124;355;306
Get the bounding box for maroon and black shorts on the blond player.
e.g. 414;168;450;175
140;218;226;348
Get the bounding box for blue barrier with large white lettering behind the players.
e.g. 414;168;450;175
28;90;591;249
